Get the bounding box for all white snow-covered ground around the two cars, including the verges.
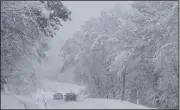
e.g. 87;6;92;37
1;81;152;109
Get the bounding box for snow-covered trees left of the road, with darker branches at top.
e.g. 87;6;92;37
1;1;71;95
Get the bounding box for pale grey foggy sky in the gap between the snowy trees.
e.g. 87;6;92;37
51;1;131;55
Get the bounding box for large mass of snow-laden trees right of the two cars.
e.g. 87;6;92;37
61;1;179;108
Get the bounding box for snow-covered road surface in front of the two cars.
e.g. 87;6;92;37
47;98;150;109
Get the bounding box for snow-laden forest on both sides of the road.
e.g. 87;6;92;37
1;1;179;109
